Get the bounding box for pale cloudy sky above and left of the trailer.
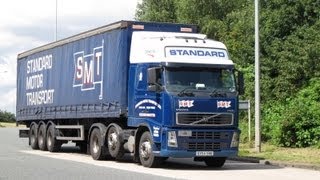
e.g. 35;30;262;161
0;0;140;113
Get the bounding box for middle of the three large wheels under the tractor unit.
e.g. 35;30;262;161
108;125;125;159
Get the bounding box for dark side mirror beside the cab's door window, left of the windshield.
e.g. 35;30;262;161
147;67;162;92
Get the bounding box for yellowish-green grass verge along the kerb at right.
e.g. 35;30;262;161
239;144;320;166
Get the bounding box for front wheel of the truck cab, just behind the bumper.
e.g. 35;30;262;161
139;131;164;168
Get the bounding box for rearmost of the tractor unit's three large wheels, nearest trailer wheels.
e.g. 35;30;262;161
90;128;107;160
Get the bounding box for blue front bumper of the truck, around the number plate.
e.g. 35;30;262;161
153;128;240;158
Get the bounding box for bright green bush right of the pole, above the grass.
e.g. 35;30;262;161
262;78;320;147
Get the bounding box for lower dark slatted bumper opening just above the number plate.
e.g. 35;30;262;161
188;142;228;151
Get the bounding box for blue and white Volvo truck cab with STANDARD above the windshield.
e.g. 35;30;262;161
128;28;240;166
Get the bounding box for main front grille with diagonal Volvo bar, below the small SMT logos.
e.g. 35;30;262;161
176;113;233;126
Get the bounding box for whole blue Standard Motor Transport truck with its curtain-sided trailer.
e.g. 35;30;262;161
16;21;244;167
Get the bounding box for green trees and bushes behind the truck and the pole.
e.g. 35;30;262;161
136;0;320;147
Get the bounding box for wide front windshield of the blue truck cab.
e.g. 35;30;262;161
164;67;236;94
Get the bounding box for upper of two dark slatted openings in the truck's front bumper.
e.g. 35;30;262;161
189;131;229;140
